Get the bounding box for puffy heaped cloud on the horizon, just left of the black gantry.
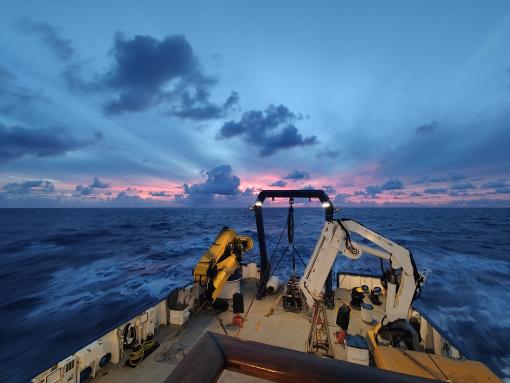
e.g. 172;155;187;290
183;165;241;198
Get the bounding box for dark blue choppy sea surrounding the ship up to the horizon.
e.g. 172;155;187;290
0;208;510;382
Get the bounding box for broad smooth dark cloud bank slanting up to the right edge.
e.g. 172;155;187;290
379;112;510;176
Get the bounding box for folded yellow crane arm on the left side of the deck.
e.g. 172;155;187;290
193;226;253;301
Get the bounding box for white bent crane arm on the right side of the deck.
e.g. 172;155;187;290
300;219;420;322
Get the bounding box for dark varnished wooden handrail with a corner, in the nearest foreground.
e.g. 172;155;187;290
165;332;438;383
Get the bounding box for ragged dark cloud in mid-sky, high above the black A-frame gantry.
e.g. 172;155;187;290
216;105;318;157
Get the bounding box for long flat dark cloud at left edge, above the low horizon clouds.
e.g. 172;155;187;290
0;123;91;162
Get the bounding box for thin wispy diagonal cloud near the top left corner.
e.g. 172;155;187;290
16;18;74;61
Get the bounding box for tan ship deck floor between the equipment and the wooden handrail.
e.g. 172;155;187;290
94;279;384;383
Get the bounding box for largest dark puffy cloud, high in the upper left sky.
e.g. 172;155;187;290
79;34;239;120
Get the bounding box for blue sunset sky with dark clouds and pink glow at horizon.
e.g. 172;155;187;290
0;0;510;207
